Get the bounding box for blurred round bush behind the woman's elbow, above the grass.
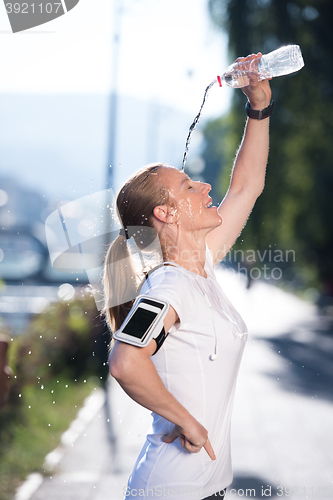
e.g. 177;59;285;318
14;297;109;384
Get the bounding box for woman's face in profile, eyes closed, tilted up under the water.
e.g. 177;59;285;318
159;167;222;231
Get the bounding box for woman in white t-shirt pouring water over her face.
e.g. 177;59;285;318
105;54;272;500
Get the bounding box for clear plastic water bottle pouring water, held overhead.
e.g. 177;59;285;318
217;45;304;88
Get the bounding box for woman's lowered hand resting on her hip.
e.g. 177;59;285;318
162;418;216;460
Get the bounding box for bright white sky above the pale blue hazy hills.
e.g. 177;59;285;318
0;0;230;117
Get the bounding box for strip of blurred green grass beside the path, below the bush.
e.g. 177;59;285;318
0;377;98;500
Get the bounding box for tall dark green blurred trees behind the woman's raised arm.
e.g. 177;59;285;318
205;0;333;286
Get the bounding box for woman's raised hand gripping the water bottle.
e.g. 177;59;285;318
235;52;272;109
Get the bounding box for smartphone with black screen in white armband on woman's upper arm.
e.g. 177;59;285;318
113;295;169;347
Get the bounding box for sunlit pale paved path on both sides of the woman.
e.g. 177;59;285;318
17;272;333;500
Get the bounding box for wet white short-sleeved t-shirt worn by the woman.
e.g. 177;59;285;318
126;247;247;500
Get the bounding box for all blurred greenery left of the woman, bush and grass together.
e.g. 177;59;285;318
0;297;110;500
